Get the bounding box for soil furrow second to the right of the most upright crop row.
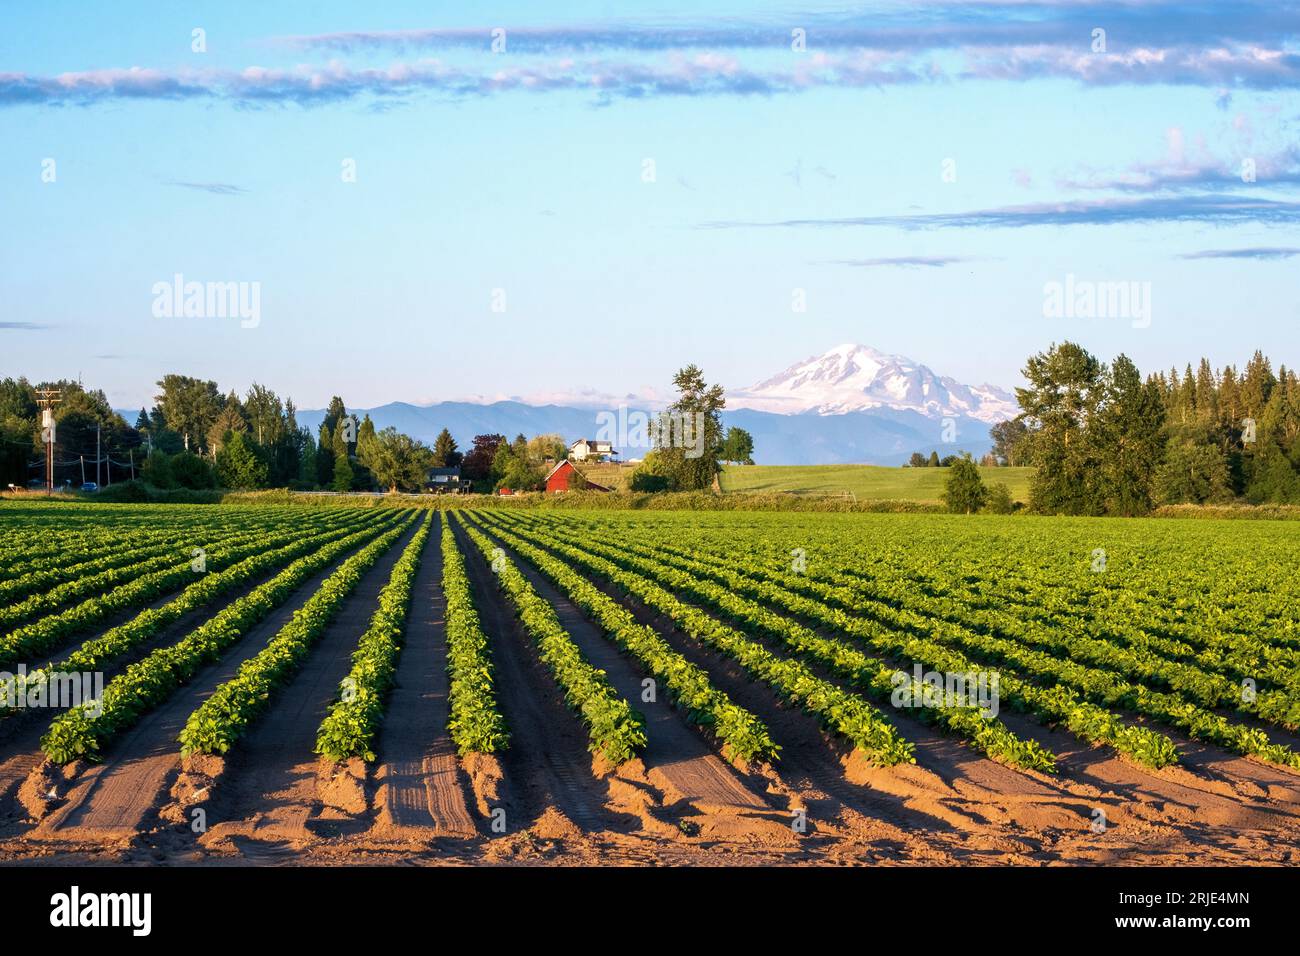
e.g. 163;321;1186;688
473;532;790;836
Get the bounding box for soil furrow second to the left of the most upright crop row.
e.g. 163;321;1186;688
199;516;420;853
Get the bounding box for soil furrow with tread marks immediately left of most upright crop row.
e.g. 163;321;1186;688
373;515;477;840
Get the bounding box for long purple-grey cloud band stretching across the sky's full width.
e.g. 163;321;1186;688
0;38;1300;107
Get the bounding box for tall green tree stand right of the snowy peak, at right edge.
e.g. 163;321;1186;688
991;342;1300;515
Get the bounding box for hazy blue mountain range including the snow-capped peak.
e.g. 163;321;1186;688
298;345;1019;464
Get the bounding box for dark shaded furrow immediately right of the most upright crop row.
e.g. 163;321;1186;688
455;527;626;832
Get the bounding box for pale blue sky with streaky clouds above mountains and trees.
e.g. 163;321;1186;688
0;0;1300;408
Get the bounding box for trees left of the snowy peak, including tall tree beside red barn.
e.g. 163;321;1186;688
0;365;754;492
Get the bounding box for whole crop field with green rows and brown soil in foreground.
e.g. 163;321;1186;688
0;502;1300;865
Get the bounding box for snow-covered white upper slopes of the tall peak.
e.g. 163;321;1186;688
727;343;1019;423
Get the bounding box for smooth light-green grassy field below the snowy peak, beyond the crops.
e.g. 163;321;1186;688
723;464;1034;502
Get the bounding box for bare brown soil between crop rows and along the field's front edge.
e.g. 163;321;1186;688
0;516;1300;865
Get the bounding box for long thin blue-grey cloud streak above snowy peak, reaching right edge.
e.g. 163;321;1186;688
698;195;1300;229
